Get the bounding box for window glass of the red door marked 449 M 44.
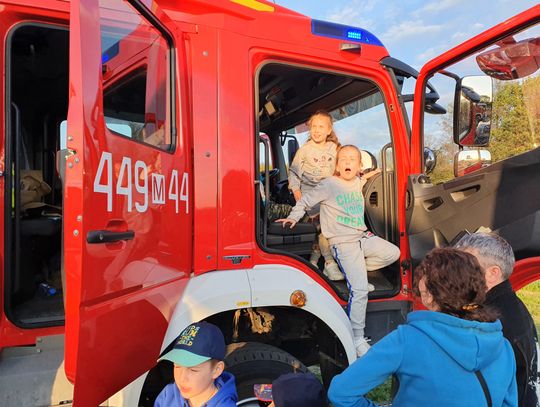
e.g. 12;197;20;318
100;0;173;150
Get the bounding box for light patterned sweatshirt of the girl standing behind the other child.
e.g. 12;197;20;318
289;140;337;193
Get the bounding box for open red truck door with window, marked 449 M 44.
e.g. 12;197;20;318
66;0;192;406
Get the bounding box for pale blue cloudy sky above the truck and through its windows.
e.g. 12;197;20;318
270;0;537;155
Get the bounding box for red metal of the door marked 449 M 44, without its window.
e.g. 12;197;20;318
64;0;192;406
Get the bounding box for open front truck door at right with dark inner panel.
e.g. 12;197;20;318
406;6;540;288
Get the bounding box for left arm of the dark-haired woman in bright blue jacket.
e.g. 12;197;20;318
328;329;403;407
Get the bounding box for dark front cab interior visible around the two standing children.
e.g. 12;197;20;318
255;63;401;299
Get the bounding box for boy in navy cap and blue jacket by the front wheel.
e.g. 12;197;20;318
154;321;237;407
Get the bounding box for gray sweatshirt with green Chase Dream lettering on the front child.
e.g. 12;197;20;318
288;176;367;244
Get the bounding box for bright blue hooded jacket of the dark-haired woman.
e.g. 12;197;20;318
328;311;517;407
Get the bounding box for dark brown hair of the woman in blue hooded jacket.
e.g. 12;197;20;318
414;248;497;322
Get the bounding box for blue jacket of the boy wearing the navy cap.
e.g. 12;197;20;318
154;372;238;407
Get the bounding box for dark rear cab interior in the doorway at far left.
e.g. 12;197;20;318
4;23;69;327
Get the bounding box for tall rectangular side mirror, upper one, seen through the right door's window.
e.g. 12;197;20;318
454;76;493;147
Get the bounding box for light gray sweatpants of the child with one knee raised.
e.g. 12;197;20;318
332;233;400;339
